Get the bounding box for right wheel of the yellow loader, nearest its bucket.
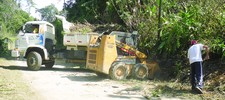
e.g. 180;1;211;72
132;63;148;79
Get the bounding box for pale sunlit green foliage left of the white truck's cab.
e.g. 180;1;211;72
0;0;33;56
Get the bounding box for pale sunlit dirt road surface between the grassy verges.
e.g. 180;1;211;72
13;60;148;100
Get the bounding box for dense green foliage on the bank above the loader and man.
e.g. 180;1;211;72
65;0;225;58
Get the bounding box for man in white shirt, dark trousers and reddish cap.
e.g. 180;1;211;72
188;40;209;94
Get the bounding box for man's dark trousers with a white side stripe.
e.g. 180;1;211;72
191;62;203;89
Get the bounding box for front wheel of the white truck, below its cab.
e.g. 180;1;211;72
27;52;42;71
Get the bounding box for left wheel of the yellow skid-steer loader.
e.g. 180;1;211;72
109;62;128;80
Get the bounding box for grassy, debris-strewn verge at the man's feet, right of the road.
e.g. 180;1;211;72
119;79;225;100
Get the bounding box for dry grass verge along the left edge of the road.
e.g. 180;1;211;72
0;58;39;100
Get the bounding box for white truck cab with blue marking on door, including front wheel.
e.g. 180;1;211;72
11;21;56;70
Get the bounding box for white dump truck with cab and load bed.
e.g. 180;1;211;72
11;21;98;71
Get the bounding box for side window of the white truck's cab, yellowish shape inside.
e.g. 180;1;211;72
24;24;39;33
